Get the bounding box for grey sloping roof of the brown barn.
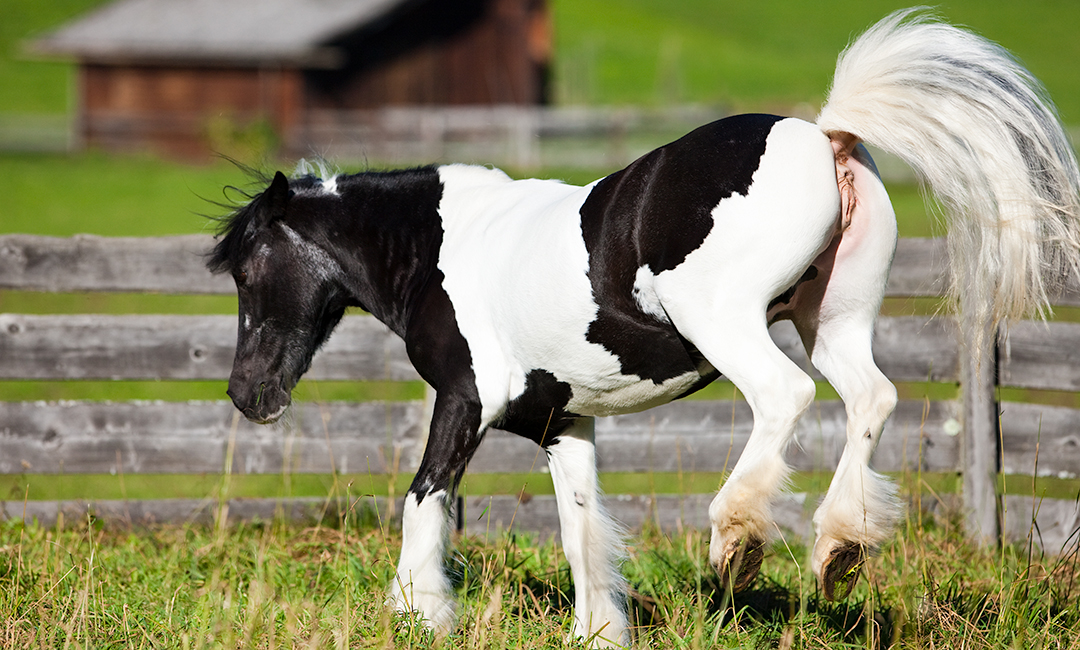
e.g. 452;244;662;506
30;0;409;68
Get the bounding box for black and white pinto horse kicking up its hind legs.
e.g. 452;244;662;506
208;11;1080;645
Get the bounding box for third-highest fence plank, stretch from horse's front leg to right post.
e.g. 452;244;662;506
469;401;960;472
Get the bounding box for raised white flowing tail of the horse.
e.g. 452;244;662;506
818;10;1080;349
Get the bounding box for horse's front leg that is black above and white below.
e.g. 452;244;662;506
389;386;482;633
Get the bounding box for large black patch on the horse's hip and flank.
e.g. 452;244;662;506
581;114;782;384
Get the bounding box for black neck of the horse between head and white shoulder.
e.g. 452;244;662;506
335;170;443;336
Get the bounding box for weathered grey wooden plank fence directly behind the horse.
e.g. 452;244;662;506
0;235;1080;551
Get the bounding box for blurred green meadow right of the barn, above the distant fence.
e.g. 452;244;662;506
552;0;1080;123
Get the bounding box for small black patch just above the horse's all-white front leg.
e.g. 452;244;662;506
494;368;580;446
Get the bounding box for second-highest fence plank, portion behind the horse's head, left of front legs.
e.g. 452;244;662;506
0;314;419;381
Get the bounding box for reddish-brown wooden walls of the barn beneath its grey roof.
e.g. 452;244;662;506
69;0;551;159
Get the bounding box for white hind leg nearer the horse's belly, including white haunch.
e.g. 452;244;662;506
653;120;840;588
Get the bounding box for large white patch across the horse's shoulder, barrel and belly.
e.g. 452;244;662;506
438;165;700;424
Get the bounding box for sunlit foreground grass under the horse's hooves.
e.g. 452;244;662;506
0;495;1080;650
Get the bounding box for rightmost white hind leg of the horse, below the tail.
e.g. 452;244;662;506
791;150;901;599
